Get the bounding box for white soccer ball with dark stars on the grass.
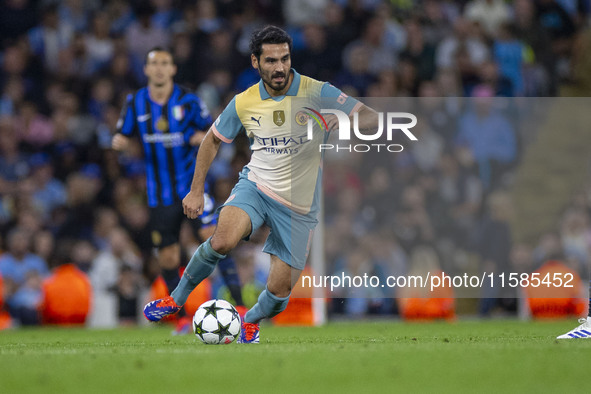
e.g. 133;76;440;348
193;300;241;345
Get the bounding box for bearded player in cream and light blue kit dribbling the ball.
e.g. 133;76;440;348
144;26;378;343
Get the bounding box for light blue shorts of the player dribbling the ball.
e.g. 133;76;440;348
221;172;318;270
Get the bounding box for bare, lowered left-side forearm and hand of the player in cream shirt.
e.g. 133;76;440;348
183;129;222;219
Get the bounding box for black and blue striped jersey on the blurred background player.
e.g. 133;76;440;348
117;84;212;207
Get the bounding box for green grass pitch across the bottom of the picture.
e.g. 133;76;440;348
0;320;591;394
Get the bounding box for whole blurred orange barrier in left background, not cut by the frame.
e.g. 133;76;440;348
40;264;92;325
